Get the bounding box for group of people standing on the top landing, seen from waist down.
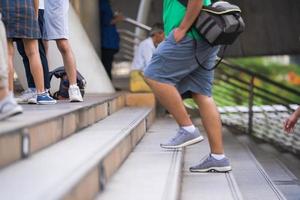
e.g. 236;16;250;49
0;0;83;118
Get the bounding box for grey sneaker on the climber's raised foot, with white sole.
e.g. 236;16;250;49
160;128;204;149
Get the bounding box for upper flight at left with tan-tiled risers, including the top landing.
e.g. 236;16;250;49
0;93;155;200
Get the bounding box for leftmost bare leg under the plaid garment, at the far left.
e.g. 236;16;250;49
7;39;14;92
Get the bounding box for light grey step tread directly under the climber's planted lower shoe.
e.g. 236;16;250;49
181;127;243;200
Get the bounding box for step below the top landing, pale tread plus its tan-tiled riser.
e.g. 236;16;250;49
0;107;154;200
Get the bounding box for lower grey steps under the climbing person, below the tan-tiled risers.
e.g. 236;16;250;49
96;118;300;200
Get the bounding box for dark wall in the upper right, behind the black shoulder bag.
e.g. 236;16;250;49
231;0;300;56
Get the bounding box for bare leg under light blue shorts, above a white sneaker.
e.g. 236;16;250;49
56;39;77;85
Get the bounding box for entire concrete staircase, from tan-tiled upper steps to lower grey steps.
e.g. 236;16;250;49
0;93;300;200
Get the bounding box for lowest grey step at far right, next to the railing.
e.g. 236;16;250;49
236;135;300;200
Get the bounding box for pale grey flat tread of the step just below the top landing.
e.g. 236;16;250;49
0;108;150;200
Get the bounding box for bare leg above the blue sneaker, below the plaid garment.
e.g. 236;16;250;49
23;39;45;93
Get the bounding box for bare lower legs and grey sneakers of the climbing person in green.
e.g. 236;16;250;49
146;79;231;172
